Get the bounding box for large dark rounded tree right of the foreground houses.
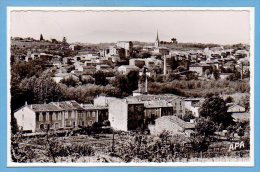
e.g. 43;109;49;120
200;96;233;127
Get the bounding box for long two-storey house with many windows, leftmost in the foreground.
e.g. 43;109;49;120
14;101;103;132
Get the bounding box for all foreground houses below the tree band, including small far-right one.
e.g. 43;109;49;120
14;94;249;135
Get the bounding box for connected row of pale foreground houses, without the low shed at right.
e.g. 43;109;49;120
14;95;185;132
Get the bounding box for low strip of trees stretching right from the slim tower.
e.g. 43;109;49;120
148;80;250;97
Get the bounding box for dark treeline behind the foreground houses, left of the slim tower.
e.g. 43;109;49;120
11;60;139;112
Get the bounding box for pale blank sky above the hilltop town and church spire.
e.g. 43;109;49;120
10;10;250;45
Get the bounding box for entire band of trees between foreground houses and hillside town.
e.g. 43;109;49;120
11;57;250;112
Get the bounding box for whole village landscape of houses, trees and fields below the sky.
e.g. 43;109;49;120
11;31;250;162
